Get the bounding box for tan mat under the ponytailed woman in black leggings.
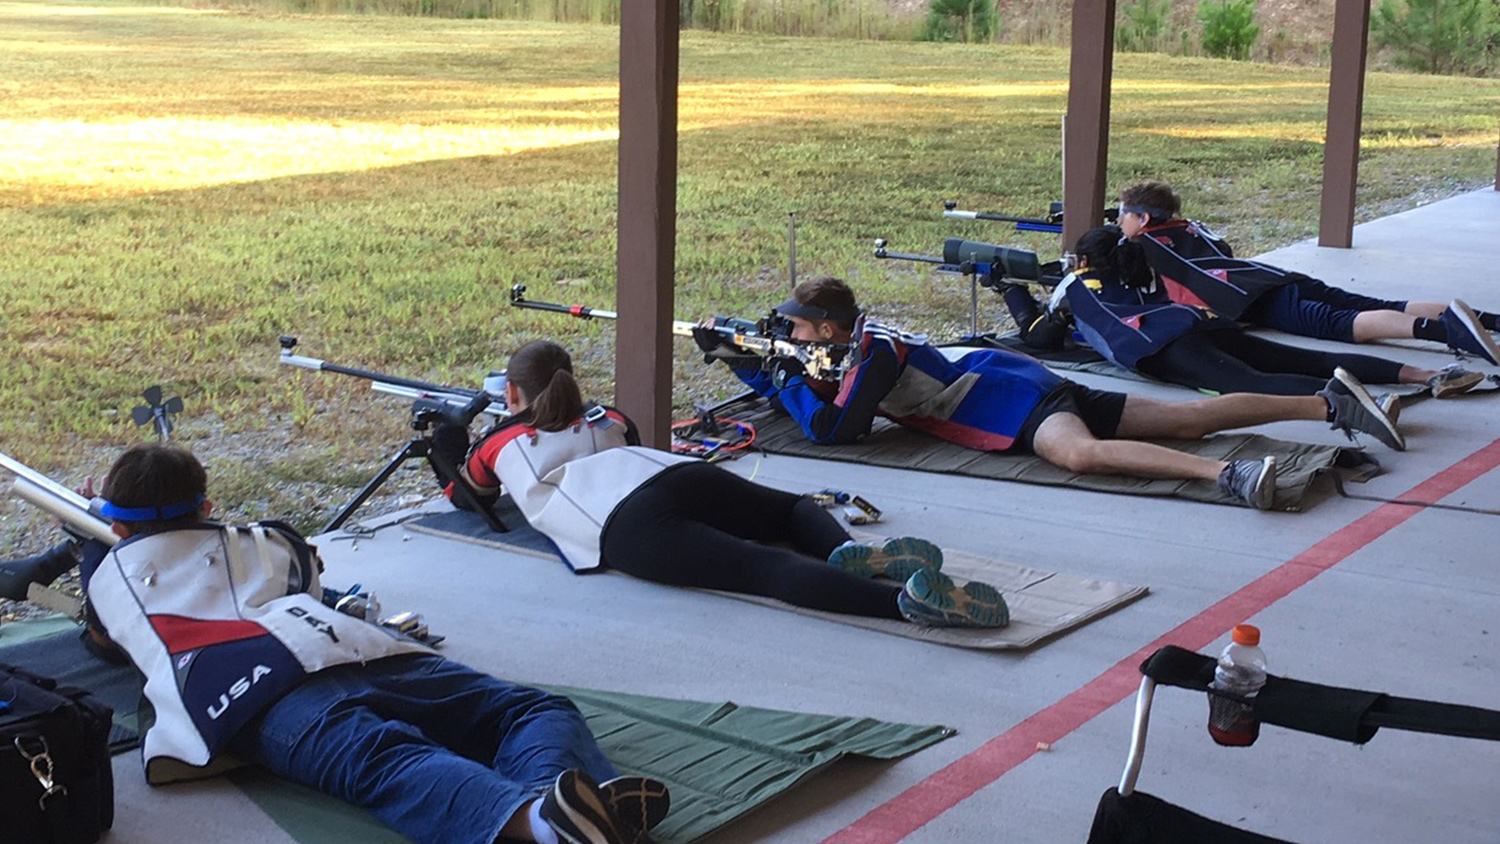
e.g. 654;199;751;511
404;498;1148;651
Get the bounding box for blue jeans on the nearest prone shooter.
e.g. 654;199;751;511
230;655;617;844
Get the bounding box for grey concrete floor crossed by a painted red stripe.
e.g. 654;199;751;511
111;190;1500;844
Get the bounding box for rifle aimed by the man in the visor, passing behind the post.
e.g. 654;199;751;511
510;285;854;381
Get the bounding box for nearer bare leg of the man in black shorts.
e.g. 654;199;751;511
1032;413;1230;481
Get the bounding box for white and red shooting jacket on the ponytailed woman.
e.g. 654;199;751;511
465;406;698;571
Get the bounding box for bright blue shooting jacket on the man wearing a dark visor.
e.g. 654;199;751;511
734;318;1064;451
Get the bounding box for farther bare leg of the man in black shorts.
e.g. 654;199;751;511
1116;393;1328;439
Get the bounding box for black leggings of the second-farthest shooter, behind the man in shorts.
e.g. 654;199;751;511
1136;328;1401;396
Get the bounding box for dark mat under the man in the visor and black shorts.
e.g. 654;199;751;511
734;405;1377;510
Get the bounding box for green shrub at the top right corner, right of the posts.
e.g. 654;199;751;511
1370;0;1500;75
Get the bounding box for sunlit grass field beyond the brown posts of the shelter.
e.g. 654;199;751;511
0;1;1500;546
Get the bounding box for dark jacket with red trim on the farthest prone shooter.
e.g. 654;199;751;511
1136;219;1299;319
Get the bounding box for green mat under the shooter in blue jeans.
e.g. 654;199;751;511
0;617;954;844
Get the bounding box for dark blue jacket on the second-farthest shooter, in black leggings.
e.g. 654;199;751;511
1059;268;1238;369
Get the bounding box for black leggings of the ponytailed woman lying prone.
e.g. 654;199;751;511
600;463;902;619
